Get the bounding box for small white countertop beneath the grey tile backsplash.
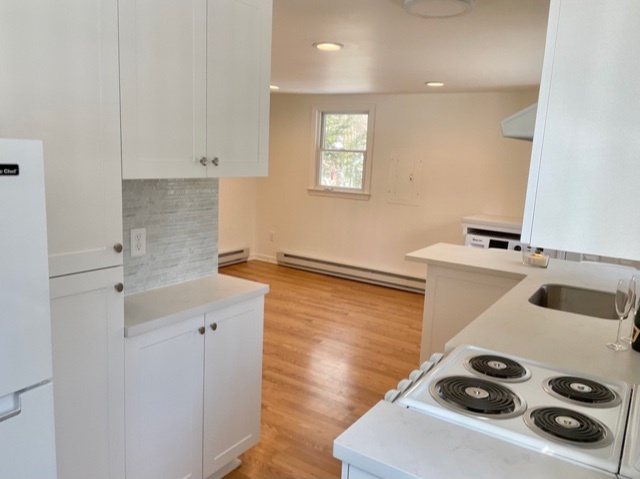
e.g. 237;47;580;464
124;274;269;337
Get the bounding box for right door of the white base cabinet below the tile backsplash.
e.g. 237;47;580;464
203;296;264;477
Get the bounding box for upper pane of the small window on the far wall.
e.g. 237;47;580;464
322;113;369;150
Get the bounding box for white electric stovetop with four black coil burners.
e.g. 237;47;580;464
395;346;631;474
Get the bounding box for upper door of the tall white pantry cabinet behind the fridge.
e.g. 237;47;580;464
0;0;122;276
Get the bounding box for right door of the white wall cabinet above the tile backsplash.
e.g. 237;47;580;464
207;0;272;177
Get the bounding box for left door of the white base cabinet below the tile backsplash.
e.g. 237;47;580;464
125;316;204;479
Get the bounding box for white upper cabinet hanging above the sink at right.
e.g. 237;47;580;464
522;0;640;260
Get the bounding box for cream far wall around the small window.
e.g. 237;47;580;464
219;91;537;277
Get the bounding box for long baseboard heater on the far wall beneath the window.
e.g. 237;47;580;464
277;252;425;293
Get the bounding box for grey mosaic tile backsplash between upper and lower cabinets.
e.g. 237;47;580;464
122;178;218;294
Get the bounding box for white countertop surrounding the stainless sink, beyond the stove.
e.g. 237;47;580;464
407;243;640;384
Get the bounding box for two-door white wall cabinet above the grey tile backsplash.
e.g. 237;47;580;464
119;0;272;179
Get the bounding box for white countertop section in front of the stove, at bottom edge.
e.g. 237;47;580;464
333;401;611;479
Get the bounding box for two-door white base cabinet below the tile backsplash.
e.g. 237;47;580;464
125;296;264;479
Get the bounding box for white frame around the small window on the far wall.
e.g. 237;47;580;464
307;103;375;200
